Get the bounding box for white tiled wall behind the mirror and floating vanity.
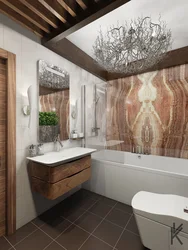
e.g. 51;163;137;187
0;15;106;228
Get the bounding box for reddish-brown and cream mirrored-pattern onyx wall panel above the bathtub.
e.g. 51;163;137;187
107;65;188;158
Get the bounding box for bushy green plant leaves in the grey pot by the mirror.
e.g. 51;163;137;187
39;112;59;126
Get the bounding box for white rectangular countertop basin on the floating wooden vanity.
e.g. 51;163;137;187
27;147;96;166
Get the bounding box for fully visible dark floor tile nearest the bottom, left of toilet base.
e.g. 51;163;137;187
93;221;123;246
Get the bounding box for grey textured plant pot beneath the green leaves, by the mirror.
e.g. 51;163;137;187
39;125;60;142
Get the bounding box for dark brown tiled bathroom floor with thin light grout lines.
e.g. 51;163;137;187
0;189;148;250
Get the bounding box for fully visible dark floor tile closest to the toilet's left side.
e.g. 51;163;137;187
106;209;131;227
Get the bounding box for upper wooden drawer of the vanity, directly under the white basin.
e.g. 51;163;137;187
31;156;91;183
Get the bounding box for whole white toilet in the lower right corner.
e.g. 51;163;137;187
132;191;188;250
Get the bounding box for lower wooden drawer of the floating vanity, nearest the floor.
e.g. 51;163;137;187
32;168;91;200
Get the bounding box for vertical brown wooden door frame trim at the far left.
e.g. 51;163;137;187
6;53;16;235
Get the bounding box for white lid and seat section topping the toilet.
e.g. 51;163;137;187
132;191;188;234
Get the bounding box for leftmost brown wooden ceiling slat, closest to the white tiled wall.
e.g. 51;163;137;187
0;0;50;33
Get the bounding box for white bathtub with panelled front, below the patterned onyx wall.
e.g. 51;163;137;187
84;150;188;205
